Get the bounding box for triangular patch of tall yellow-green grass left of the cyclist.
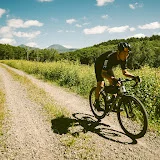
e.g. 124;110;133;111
1;60;96;96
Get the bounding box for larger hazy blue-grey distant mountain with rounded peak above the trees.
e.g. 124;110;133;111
47;44;77;53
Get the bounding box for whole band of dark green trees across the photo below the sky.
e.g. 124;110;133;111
0;35;160;69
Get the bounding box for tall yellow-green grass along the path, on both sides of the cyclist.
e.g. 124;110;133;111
1;60;160;130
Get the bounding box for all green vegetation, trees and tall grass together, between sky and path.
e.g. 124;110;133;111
0;35;160;130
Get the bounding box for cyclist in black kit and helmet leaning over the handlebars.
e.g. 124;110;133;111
95;42;140;111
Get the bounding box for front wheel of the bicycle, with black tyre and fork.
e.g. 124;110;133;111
117;95;148;139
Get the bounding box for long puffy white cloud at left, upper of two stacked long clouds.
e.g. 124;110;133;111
7;19;43;28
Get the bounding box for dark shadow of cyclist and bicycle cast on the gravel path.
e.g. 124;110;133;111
51;113;137;144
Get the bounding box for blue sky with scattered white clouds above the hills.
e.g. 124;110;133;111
0;0;160;48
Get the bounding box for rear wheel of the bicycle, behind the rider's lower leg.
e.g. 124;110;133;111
89;87;107;119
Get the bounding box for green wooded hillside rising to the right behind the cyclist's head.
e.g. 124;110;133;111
61;35;160;69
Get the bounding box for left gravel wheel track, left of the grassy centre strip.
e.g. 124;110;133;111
0;65;63;160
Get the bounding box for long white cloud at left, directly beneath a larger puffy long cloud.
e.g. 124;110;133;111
13;31;41;39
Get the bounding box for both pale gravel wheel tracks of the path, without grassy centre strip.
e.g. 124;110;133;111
0;64;160;160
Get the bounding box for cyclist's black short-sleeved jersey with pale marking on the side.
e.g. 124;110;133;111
95;51;127;70
